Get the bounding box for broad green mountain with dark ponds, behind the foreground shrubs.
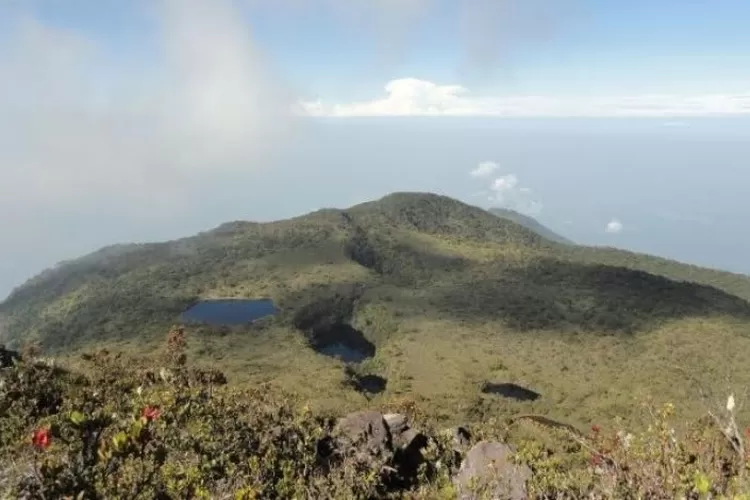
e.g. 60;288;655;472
0;193;750;428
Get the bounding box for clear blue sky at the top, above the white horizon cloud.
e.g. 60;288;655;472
8;0;750;100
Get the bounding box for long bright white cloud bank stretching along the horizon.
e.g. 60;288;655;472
302;78;750;117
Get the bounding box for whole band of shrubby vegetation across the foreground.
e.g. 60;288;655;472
0;329;750;500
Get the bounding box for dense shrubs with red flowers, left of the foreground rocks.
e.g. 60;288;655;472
0;329;452;499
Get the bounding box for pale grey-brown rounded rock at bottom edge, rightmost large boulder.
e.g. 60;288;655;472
453;441;531;500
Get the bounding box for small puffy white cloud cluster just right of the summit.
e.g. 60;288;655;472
469;161;543;215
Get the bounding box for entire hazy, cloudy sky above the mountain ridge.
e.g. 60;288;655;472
0;0;750;297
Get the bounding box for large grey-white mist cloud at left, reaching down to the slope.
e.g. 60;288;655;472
0;0;296;295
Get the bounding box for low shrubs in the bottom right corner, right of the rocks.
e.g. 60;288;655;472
526;398;750;500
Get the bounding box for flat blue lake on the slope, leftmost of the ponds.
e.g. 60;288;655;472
181;299;277;326
